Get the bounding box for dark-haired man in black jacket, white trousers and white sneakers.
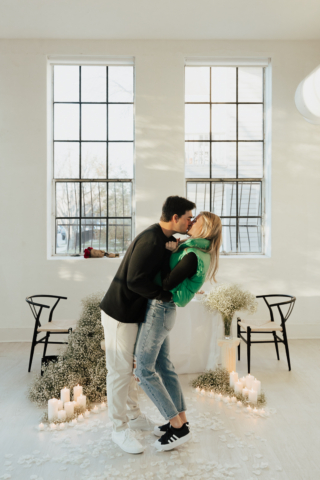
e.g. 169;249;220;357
100;196;195;453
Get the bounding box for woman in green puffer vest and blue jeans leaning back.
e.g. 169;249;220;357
134;212;222;450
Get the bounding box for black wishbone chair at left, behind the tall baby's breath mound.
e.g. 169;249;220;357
26;295;76;372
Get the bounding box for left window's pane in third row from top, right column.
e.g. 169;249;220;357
108;142;133;178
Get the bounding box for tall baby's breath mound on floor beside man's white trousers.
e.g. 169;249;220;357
28;294;107;406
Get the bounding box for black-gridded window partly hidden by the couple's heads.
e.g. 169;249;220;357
185;66;264;254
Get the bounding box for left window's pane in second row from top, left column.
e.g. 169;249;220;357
54;103;79;140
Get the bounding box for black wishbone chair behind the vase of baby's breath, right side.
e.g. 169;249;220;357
237;295;296;373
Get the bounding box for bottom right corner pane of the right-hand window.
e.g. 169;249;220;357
238;218;262;253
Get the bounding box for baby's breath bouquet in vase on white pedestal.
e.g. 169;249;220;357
204;283;258;338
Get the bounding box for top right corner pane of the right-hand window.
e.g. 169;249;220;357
238;67;263;102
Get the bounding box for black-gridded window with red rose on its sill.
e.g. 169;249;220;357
53;65;134;255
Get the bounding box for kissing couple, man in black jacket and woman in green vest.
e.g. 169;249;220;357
100;196;222;454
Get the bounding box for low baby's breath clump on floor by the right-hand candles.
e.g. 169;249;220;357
190;367;266;407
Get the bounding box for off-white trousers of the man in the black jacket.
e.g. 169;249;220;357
101;310;141;432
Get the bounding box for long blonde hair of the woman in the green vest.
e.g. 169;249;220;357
197;212;222;282
